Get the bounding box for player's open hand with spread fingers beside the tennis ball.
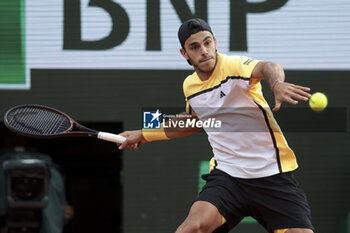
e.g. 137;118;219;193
272;82;311;112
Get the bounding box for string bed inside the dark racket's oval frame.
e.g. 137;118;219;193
8;107;72;135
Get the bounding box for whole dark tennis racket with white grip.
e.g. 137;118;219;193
4;104;125;143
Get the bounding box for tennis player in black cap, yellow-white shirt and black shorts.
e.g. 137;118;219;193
119;18;314;233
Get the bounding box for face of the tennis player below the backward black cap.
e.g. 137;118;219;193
180;31;217;72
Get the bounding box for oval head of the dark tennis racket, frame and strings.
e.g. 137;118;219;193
4;104;74;138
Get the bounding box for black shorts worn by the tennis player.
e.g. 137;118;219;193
196;169;314;232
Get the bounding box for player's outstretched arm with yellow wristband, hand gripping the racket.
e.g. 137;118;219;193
118;112;202;150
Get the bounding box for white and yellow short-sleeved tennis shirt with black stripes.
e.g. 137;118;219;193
183;53;298;178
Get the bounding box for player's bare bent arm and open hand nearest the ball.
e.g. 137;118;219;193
251;61;311;112
